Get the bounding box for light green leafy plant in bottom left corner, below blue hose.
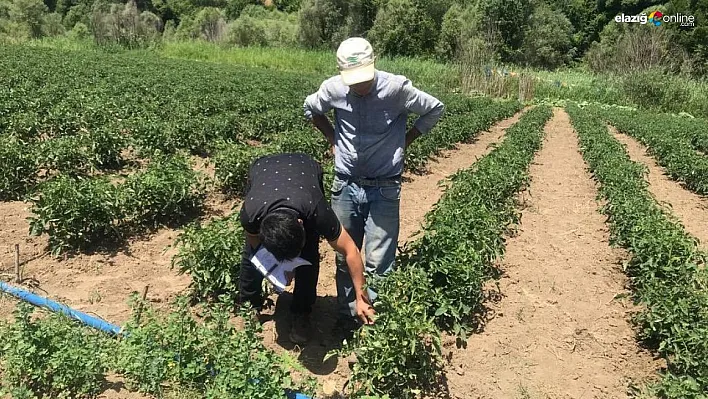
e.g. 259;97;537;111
0;302;109;398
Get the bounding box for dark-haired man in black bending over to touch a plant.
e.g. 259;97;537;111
239;154;374;344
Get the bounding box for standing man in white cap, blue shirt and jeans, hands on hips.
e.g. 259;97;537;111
304;37;444;331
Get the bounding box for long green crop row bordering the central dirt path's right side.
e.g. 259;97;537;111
567;105;708;399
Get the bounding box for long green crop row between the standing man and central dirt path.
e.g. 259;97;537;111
338;107;551;398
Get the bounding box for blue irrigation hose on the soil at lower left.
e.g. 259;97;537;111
0;281;314;399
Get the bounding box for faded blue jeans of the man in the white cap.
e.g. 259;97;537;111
332;176;401;316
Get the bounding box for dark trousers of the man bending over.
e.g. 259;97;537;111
239;232;320;314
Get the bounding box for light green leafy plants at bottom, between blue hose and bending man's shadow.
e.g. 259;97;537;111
115;298;313;399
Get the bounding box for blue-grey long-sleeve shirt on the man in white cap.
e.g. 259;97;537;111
304;70;445;178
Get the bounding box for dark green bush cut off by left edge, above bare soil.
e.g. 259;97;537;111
0;136;37;200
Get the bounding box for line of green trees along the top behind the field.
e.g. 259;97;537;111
0;0;708;76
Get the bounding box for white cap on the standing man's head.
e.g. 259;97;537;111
337;37;375;86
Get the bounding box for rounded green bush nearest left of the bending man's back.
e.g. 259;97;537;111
121;156;205;227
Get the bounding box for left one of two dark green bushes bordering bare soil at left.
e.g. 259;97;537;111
29;176;121;256
